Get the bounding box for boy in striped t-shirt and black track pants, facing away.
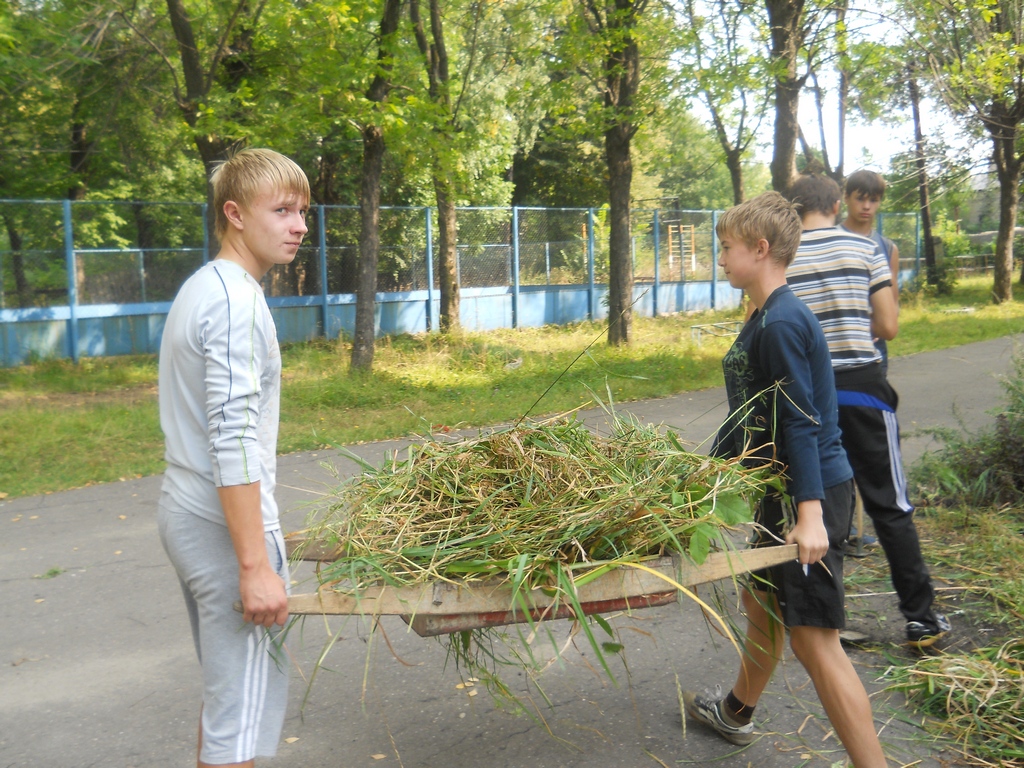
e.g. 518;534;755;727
786;174;950;648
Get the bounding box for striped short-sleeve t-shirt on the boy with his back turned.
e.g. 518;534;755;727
785;227;892;369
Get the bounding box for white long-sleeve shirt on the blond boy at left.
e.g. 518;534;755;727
160;259;281;530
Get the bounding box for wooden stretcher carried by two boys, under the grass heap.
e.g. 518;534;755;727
280;540;797;637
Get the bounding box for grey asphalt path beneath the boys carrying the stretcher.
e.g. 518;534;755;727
0;336;1024;768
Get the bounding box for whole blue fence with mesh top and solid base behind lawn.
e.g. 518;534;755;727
0;200;919;366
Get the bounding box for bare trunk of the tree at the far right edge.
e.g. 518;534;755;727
985;110;1021;304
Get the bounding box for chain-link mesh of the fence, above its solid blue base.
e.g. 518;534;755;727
0;201;918;309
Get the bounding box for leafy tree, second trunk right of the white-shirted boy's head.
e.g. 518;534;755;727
406;0;551;331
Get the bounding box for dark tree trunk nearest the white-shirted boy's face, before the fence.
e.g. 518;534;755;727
350;0;401;373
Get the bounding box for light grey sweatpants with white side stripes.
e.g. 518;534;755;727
158;500;289;765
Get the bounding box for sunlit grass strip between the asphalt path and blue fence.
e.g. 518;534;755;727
0;278;1024;498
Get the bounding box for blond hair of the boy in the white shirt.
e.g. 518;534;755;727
210;148;310;240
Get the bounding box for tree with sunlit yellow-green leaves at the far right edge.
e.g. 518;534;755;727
905;0;1024;303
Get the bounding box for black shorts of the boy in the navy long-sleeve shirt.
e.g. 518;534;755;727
751;479;854;630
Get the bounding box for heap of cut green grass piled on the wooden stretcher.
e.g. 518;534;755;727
300;416;777;712
